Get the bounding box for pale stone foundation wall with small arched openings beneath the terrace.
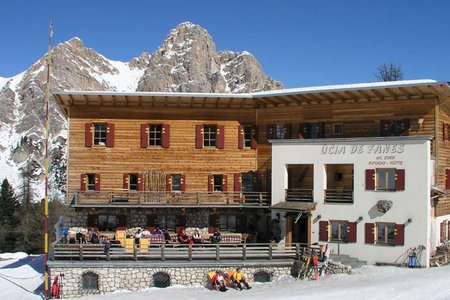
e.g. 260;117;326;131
50;263;292;297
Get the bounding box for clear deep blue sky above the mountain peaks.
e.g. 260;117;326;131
0;0;450;88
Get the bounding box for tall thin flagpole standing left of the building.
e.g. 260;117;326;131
44;21;53;299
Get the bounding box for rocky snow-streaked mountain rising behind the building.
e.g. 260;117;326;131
0;22;283;201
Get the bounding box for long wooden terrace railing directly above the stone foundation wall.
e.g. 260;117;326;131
52;243;322;261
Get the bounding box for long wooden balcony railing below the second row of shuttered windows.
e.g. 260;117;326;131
72;191;270;206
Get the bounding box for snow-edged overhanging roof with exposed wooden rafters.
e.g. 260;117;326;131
52;79;450;114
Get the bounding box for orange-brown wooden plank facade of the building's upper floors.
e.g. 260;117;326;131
54;81;450;237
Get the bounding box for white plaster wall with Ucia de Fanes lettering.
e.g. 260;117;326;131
272;137;432;266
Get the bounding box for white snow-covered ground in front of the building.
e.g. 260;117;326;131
0;253;450;300
